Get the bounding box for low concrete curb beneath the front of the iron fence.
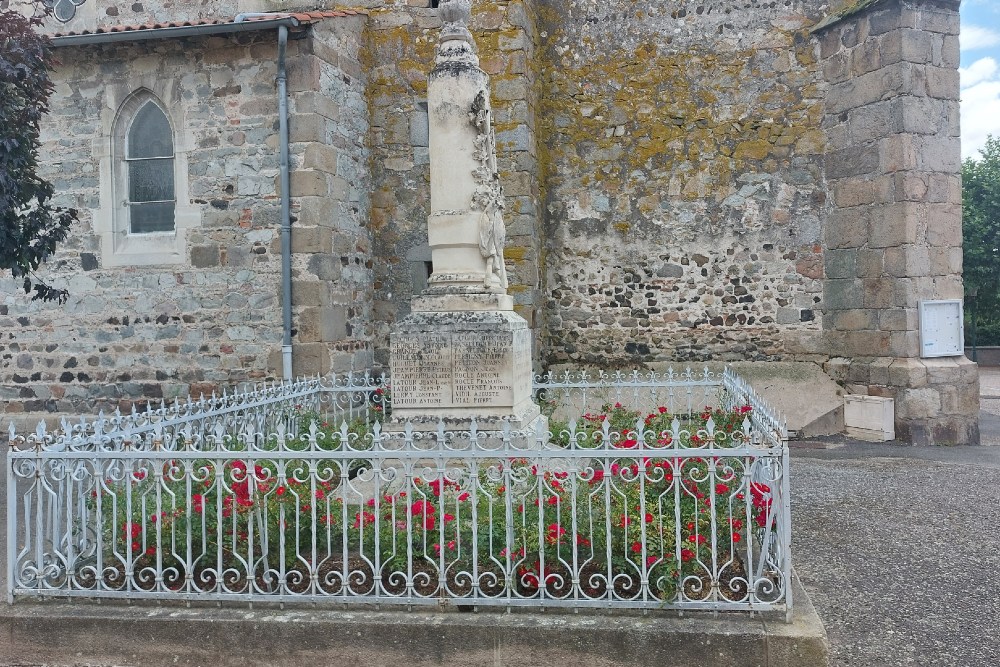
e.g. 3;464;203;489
0;577;829;667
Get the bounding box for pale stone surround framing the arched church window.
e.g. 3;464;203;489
94;85;201;267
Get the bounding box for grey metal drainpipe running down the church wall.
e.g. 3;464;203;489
233;12;292;381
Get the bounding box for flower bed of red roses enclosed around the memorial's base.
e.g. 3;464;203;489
74;404;784;606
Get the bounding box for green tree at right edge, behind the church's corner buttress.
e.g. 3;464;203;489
962;136;1000;345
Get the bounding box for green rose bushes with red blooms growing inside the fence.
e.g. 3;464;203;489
89;404;773;602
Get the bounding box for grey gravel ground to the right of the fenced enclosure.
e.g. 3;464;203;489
791;438;1000;667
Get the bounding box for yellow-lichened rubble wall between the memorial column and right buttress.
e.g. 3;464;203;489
539;0;827;366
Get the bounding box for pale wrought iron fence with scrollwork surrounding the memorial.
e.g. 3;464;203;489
8;372;791;613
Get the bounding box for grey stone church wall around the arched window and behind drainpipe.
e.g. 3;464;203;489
0;17;372;416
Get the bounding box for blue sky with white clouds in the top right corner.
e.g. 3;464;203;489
959;0;1000;158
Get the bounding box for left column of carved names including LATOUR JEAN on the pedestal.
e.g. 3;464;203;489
390;334;452;408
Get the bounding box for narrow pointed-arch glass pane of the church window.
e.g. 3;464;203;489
125;101;175;234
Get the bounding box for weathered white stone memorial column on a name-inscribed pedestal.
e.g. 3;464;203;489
389;0;541;430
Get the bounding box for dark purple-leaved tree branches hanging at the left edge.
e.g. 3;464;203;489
0;1;77;303
